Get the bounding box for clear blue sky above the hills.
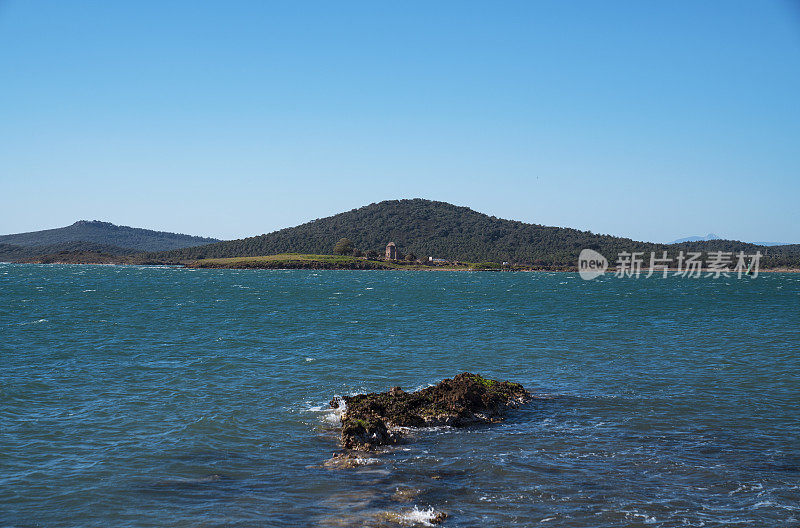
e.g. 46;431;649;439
0;0;800;242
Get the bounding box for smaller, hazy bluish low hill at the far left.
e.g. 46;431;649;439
0;220;218;252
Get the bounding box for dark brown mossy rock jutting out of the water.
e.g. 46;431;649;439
331;372;531;450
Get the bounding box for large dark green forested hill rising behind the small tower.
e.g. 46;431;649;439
157;199;800;266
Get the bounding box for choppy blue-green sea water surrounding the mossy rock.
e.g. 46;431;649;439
0;264;800;528
